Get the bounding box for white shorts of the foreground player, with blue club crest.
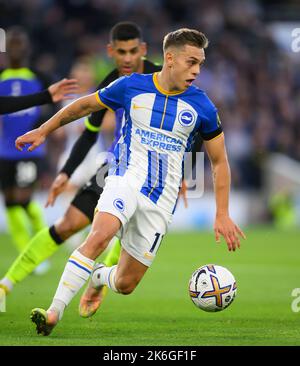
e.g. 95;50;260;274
97;176;172;267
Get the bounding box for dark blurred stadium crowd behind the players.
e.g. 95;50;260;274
0;0;300;190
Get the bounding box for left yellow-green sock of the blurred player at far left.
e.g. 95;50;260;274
6;205;30;252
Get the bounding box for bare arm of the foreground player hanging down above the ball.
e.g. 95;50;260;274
204;133;246;251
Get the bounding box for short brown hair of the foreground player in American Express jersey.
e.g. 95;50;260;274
163;28;208;52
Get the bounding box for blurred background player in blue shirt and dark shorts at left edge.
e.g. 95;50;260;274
0;27;57;264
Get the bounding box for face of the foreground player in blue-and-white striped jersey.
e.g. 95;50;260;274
167;45;205;90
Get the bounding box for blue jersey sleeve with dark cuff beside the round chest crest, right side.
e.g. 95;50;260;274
200;105;223;141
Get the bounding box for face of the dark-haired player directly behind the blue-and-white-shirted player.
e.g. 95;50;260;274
107;38;147;75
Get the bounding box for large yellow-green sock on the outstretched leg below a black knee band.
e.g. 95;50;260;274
4;227;59;284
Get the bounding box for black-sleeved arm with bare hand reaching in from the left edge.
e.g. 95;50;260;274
0;79;77;114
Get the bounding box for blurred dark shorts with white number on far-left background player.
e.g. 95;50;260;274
0;158;44;190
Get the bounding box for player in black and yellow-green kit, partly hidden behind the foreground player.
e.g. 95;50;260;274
0;22;161;304
